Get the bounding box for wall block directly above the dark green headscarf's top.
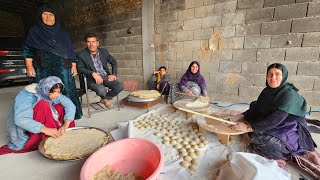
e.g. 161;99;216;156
257;49;286;62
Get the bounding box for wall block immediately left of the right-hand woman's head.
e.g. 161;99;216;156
241;62;268;75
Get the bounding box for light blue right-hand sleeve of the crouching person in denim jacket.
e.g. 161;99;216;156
55;94;76;121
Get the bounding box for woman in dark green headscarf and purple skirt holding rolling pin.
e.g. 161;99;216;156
231;63;320;177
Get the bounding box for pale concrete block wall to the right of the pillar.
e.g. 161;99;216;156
155;0;320;106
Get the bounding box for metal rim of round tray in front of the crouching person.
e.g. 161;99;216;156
38;126;110;161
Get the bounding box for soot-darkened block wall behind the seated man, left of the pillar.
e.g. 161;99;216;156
53;0;142;89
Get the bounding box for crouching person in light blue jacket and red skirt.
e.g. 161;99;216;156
0;76;76;155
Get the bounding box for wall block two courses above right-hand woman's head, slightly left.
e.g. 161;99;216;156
244;36;271;49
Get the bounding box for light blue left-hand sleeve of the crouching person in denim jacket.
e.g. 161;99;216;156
14;91;44;133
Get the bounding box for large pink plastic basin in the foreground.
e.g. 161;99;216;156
80;138;164;180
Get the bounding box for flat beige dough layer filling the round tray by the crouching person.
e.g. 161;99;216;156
44;129;108;160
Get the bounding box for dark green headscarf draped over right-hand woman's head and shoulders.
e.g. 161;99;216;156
255;63;307;117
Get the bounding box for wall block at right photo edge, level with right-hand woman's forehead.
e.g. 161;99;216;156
297;62;320;76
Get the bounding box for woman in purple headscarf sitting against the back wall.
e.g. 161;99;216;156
168;61;208;103
